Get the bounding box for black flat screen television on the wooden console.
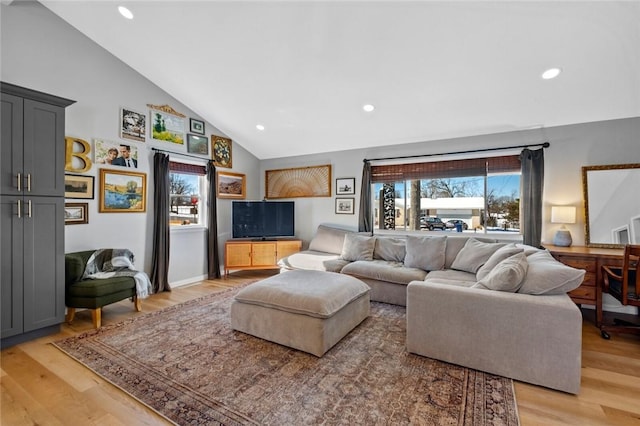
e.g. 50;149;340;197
231;201;295;240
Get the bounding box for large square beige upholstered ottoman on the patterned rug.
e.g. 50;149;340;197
231;271;370;357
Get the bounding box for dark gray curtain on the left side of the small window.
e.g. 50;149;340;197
151;152;171;293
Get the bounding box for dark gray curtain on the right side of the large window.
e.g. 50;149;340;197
520;148;544;247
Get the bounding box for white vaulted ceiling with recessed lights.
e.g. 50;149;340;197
41;0;640;159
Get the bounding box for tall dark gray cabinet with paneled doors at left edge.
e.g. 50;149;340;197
0;83;73;347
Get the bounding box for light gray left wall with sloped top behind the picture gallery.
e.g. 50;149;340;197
0;2;259;283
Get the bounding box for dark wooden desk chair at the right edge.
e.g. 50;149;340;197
597;245;640;339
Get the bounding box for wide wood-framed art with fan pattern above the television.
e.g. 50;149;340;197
265;164;331;199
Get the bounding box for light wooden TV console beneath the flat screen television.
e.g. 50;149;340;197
224;239;302;276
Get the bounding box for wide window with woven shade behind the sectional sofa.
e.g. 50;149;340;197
371;155;520;233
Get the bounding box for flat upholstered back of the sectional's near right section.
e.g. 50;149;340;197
407;281;582;393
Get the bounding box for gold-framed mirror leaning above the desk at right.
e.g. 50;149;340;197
582;164;640;248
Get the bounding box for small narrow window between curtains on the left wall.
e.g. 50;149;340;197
169;161;207;226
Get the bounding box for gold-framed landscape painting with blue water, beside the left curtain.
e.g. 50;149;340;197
98;169;147;213
